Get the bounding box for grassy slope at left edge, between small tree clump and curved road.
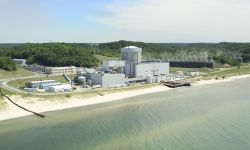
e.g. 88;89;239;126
0;67;34;79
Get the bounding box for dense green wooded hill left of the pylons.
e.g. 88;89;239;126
0;43;99;67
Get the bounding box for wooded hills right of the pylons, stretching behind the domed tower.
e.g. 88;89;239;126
96;41;250;63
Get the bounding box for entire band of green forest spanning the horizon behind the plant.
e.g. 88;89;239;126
0;40;250;70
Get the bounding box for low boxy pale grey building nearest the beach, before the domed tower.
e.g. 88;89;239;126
91;73;127;87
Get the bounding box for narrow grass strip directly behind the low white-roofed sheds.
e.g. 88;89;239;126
8;75;67;89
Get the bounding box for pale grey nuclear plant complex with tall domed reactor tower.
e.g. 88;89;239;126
79;46;169;87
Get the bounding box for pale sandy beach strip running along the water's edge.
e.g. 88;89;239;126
0;74;250;121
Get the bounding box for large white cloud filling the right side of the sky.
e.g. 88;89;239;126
92;0;250;42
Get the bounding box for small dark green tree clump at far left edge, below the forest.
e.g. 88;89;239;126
0;57;17;71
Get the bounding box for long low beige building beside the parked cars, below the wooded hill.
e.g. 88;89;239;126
45;66;76;75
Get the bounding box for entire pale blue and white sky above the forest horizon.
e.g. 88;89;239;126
0;0;250;43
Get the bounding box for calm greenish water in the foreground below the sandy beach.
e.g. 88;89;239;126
0;79;250;150
